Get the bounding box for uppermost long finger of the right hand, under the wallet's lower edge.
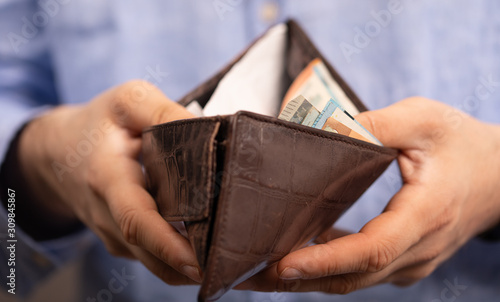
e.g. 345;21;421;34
278;185;428;280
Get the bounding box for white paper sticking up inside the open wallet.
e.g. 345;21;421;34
199;24;288;116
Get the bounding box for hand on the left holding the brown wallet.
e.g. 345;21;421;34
20;81;200;284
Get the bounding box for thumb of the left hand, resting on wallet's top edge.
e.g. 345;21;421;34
104;81;194;132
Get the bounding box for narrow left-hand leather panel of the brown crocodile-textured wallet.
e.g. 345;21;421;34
143;118;220;267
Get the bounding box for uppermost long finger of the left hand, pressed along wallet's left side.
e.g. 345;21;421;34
90;156;201;281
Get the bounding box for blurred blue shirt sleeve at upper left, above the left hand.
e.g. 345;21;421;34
0;0;58;161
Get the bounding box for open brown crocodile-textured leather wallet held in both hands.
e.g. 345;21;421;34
143;20;397;301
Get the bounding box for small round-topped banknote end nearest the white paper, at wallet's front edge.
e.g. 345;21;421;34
278;95;320;127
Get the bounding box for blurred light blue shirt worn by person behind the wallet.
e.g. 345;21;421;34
0;0;500;301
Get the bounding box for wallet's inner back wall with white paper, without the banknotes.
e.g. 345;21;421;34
179;20;366;116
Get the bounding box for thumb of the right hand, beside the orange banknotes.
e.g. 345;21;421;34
355;98;443;149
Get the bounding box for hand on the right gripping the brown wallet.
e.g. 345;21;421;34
240;98;500;294
